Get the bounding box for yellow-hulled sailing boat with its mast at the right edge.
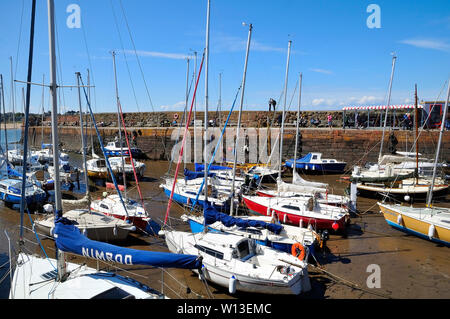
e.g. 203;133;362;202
378;79;450;246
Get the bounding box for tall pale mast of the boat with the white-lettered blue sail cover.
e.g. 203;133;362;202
47;0;66;281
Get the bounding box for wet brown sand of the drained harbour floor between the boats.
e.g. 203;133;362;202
0;159;450;300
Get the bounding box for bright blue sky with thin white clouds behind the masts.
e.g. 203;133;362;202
0;0;450;112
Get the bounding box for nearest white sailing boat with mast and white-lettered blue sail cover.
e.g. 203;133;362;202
9;0;201;299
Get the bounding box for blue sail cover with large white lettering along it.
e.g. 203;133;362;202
54;217;202;269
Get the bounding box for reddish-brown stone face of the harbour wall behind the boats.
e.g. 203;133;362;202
25;125;450;165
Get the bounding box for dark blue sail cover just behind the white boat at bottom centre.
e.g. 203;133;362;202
203;205;283;234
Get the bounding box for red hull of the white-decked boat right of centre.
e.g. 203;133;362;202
244;196;346;230
